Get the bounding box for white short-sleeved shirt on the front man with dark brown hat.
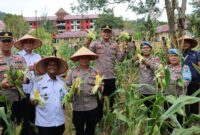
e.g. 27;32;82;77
31;74;67;127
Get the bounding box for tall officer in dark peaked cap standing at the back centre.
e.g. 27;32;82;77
89;25;125;119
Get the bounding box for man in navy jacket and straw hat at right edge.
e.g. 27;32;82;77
179;35;200;116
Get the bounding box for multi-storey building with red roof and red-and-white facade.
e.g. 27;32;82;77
25;8;98;38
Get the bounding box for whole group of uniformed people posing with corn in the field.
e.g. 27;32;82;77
0;25;200;135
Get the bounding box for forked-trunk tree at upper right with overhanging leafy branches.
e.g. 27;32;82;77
73;0;187;45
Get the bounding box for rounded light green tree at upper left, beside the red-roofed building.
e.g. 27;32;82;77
3;14;29;38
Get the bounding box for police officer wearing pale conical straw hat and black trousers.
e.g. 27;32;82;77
66;47;98;135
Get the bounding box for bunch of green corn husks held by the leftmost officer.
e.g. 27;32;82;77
5;65;26;99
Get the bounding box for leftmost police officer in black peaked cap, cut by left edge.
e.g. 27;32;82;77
0;32;26;132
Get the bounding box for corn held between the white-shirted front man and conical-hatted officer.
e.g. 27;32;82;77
62;77;83;105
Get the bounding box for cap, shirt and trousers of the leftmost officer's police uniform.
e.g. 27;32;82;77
0;32;26;133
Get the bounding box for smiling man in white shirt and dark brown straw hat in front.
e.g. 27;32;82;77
31;57;68;135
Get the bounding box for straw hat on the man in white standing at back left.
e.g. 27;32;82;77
14;34;42;50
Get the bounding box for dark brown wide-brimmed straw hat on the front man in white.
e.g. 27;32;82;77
36;56;68;75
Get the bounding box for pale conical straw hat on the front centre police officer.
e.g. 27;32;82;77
70;47;98;61
